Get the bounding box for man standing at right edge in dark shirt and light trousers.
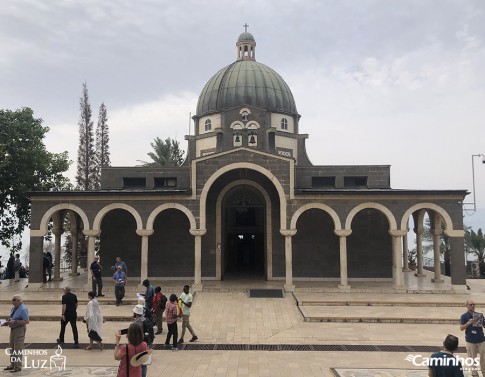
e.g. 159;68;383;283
460;299;485;376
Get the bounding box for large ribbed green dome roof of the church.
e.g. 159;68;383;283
197;59;298;117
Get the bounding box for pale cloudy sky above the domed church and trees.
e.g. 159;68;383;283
0;0;485;258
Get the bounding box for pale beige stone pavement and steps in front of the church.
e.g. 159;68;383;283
0;275;485;377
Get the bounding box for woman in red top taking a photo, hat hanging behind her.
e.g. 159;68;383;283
114;323;149;377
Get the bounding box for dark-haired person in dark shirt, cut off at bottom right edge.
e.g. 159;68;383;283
428;335;464;377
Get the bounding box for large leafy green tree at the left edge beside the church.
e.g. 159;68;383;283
0;108;72;252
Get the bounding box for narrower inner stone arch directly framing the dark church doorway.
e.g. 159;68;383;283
216;179;273;280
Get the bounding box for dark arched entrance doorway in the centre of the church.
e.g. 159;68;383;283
222;185;266;280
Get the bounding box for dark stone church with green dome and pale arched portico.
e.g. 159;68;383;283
29;31;467;292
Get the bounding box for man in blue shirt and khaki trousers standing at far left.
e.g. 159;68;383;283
2;295;29;373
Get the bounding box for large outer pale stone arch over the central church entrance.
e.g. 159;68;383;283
200;162;286;229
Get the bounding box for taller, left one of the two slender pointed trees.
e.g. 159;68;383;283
76;82;99;190
